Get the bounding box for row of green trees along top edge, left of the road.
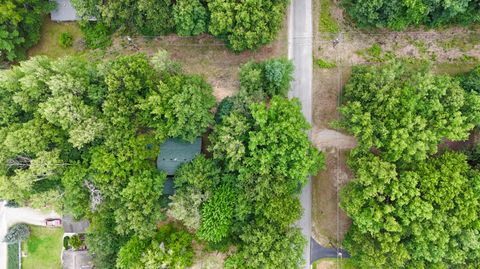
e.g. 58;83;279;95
72;0;288;51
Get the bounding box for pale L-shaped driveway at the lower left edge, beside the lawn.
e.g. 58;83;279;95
0;201;59;269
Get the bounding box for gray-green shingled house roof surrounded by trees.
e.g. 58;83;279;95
157;138;202;176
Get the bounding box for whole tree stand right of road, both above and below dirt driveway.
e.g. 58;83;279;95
340;63;480;268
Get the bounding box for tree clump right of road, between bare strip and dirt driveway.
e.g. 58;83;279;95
340;63;480;162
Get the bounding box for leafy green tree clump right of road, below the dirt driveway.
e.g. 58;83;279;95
342;152;480;268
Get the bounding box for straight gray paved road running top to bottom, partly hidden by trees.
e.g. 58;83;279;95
288;0;312;268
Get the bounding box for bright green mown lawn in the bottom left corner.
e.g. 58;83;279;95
22;226;63;269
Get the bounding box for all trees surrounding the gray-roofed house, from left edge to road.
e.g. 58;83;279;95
0;52;323;269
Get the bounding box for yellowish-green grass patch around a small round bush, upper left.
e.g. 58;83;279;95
28;19;83;58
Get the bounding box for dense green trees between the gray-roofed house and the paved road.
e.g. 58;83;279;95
169;60;324;268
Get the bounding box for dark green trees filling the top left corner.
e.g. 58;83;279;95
0;0;54;62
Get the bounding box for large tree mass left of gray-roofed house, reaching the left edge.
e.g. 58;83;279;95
0;52;215;268
